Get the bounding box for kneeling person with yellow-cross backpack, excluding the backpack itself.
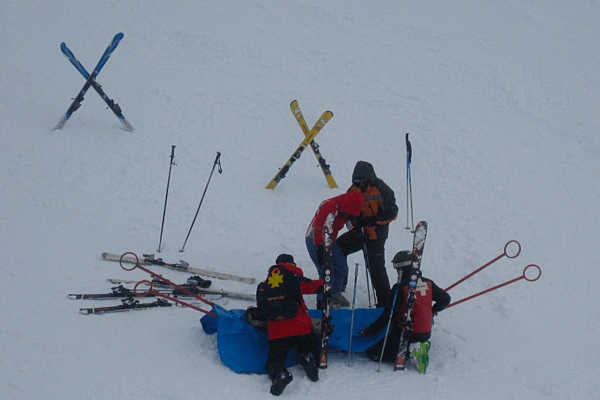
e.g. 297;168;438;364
257;254;323;396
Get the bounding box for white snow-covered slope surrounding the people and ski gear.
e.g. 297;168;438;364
0;0;600;400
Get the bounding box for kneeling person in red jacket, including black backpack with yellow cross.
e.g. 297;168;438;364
256;254;323;396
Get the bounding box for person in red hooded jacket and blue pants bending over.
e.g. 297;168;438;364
306;192;364;308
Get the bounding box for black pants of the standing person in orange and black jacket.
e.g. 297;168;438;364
336;225;390;307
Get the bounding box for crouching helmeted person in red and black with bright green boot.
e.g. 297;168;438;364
359;250;451;373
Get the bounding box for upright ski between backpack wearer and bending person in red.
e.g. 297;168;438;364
319;214;335;368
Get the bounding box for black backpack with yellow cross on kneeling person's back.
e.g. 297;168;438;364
256;265;302;321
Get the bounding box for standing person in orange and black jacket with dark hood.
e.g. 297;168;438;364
336;161;398;307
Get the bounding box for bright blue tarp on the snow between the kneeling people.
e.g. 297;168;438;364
200;305;385;374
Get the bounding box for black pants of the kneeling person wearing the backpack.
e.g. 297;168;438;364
265;333;319;380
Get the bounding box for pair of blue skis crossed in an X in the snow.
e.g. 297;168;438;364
53;33;133;132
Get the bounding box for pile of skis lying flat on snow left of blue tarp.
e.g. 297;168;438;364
68;253;255;314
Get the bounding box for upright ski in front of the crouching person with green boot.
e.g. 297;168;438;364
394;221;427;371
